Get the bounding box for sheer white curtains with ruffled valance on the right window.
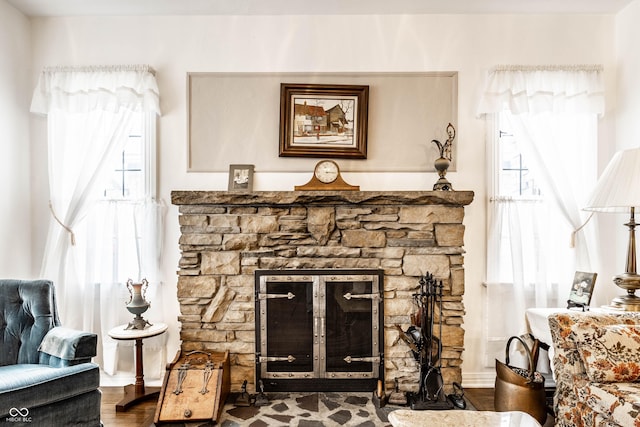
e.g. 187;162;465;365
479;66;604;366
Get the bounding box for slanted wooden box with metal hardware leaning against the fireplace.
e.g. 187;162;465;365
154;351;231;424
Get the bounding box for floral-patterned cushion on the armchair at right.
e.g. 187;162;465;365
571;323;640;383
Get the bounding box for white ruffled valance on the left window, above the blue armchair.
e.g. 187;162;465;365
31;65;160;115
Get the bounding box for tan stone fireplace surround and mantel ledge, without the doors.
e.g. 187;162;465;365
171;191;474;392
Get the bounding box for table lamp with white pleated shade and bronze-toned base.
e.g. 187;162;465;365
584;148;640;311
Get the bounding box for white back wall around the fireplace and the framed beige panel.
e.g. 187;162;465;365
27;15;616;386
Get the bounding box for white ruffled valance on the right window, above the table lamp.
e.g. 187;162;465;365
478;65;604;115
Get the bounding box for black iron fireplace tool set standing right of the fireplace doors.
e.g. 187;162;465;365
397;273;466;410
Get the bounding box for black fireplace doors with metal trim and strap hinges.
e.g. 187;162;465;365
255;269;384;391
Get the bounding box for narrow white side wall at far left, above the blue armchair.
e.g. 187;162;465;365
0;0;32;278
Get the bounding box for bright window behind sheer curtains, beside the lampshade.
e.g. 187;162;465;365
487;112;597;307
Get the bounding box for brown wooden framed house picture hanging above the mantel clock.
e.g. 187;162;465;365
278;83;369;159
